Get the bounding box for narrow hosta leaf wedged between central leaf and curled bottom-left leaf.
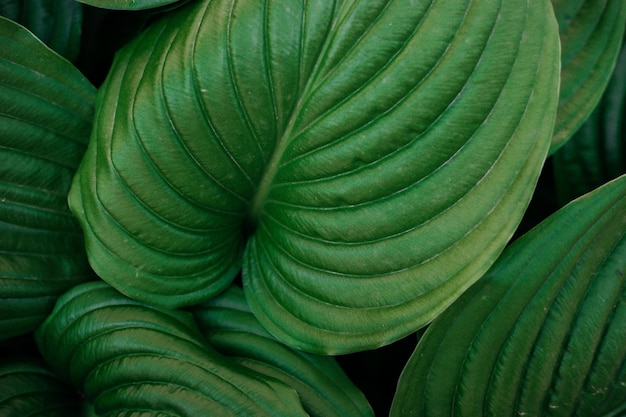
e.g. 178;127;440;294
193;286;374;417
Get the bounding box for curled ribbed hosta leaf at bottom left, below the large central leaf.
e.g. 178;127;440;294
35;281;306;417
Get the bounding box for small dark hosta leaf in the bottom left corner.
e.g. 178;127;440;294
0;357;81;417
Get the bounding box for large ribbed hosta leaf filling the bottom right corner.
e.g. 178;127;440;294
391;176;626;417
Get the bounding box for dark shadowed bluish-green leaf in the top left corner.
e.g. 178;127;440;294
0;0;83;61
